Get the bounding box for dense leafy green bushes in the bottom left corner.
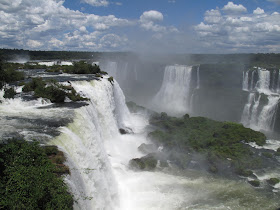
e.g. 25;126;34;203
0;140;73;209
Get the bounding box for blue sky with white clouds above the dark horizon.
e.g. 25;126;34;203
0;0;280;53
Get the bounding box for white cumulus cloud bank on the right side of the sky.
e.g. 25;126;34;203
194;2;280;52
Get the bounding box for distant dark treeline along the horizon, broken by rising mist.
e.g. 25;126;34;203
0;49;280;67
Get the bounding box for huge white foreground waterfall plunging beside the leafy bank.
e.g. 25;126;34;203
52;79;130;209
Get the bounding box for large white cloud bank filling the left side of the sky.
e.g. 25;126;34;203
0;0;137;50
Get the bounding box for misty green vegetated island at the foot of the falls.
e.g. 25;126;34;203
149;113;266;176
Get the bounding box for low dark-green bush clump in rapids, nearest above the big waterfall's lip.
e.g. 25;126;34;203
22;77;88;103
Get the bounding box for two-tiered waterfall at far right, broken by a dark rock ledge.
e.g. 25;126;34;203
241;68;280;131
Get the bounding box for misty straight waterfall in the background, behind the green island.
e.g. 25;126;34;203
153;65;192;115
